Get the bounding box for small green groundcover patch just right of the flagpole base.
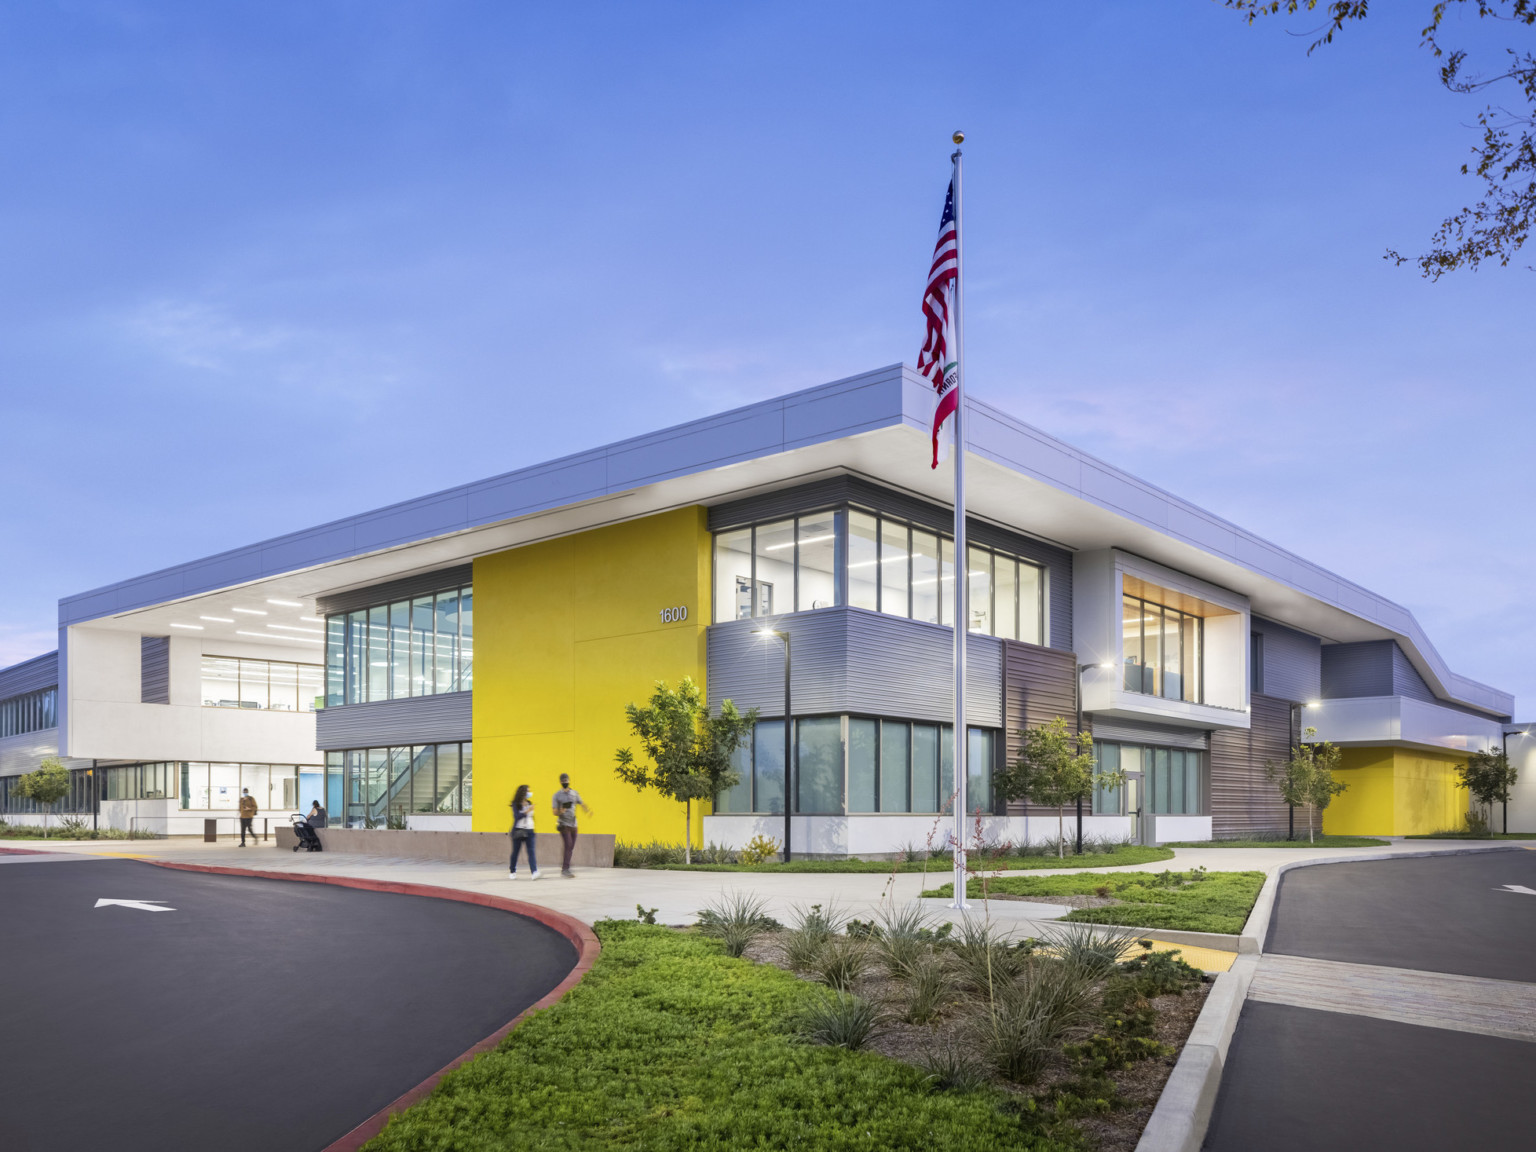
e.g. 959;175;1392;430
923;872;1264;934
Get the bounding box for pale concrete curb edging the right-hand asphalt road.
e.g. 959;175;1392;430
1137;843;1521;1152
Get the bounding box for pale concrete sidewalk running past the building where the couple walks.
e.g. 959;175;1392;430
0;837;1508;935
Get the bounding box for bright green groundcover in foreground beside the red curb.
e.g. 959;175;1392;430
367;920;1081;1152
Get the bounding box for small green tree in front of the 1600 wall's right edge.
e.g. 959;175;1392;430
614;676;757;863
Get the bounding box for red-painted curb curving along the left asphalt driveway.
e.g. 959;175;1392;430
144;848;602;1152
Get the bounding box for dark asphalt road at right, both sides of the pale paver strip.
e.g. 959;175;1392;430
1204;851;1536;1152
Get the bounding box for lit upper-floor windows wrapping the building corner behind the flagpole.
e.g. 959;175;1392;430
714;508;1046;644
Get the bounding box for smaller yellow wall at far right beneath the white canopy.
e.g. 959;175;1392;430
1322;748;1467;836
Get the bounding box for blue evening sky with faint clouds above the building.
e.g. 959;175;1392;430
0;0;1536;716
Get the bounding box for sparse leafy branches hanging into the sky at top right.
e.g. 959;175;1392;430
1223;0;1536;280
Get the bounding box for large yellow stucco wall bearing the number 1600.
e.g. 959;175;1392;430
473;507;711;843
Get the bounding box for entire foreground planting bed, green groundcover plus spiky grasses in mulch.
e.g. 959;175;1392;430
367;897;1206;1152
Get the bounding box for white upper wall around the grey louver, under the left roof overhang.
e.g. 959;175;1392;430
63;625;324;763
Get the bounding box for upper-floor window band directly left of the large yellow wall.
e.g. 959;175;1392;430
326;587;475;707
